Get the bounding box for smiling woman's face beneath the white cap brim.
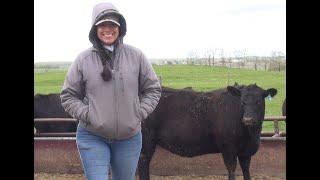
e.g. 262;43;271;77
97;22;119;45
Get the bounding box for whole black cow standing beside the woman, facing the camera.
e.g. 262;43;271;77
138;84;277;180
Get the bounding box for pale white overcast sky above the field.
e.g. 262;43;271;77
34;0;286;62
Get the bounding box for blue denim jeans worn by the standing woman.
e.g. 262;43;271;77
76;126;142;180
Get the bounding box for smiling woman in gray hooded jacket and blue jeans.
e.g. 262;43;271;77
61;3;161;180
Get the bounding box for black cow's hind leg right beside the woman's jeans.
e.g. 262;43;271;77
138;130;156;180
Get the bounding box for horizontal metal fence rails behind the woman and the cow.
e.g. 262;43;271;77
34;116;286;137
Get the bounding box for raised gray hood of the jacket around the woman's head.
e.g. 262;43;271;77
89;3;127;47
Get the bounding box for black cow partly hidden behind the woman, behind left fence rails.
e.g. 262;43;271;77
34;93;77;133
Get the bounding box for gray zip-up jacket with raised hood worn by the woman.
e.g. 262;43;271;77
60;3;161;139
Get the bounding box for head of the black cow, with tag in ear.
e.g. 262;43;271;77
227;84;277;126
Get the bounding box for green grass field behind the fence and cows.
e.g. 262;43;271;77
34;65;286;132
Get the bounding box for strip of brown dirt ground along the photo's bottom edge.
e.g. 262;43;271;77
34;173;285;180
